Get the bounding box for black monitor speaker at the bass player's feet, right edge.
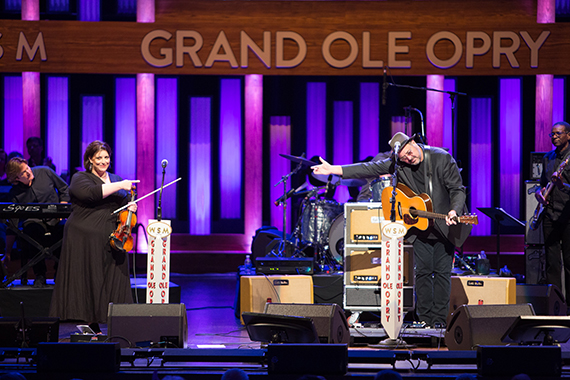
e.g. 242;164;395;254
517;284;568;316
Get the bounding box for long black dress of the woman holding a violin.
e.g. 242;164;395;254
50;172;133;323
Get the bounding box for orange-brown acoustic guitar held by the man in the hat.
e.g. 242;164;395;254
382;183;479;231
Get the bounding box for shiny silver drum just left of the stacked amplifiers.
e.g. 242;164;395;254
301;199;343;246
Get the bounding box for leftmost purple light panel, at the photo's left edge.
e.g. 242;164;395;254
4;75;24;154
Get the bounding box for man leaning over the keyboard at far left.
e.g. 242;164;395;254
6;157;70;288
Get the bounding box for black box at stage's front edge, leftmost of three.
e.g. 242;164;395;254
37;342;121;373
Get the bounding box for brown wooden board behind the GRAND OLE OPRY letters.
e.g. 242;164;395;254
0;0;570;75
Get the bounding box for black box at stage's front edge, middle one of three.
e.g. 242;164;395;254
265;343;348;379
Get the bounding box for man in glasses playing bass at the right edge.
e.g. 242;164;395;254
535;121;570;298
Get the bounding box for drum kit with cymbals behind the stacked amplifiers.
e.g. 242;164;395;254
272;154;370;272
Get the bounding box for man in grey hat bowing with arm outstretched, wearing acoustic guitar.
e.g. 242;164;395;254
313;132;472;328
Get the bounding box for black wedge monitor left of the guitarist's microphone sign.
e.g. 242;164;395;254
265;303;350;343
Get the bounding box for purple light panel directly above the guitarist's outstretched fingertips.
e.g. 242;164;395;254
306;82;327;159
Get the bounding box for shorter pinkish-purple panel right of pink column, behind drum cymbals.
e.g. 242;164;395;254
269;116;291;232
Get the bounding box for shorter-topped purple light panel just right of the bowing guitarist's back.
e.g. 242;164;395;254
467;98;493;236
